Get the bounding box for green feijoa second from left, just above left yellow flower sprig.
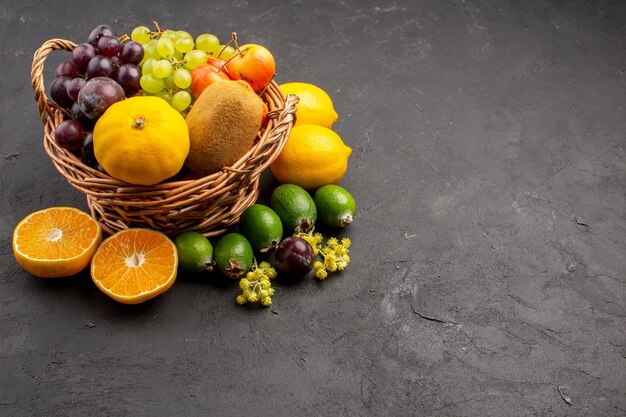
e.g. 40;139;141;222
214;233;252;279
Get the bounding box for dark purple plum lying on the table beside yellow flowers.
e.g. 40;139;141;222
274;237;315;279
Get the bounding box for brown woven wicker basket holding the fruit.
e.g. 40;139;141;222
31;39;298;237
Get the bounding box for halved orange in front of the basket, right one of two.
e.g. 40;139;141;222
91;228;178;304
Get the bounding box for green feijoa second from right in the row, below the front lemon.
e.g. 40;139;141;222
270;184;317;234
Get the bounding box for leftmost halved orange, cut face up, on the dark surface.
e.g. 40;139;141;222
13;207;102;278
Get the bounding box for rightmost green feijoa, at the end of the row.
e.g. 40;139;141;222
313;184;356;227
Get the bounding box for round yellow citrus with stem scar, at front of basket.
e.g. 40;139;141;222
93;96;189;185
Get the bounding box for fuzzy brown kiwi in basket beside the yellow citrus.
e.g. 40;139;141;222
185;80;263;175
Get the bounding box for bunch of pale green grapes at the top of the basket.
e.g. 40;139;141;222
130;23;235;115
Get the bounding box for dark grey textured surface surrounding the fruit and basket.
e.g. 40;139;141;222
0;0;626;416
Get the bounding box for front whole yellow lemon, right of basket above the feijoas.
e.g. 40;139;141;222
270;125;352;190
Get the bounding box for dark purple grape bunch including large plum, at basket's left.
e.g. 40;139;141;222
50;25;144;168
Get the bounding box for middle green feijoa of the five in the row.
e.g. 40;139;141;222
239;204;283;253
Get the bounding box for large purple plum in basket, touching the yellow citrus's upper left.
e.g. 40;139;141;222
78;77;125;119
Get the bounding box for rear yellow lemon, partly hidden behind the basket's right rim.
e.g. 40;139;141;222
280;83;339;129
